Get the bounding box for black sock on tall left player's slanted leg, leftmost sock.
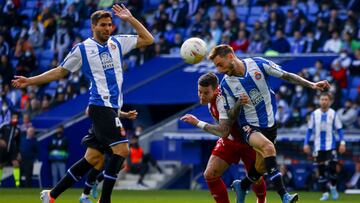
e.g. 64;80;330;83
50;158;93;199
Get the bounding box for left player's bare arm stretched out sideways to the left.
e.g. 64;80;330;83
12;66;69;88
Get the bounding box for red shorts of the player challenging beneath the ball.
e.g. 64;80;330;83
211;138;256;171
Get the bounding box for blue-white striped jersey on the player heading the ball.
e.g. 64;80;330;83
220;57;284;128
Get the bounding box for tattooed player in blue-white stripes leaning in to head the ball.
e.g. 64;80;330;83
209;45;330;203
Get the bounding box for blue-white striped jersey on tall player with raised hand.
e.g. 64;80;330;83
60;35;137;108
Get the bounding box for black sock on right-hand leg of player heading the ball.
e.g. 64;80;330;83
264;156;287;199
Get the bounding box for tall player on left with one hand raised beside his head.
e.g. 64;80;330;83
12;5;154;203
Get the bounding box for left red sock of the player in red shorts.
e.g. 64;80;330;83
206;177;230;203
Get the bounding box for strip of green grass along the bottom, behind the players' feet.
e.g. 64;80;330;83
0;188;360;203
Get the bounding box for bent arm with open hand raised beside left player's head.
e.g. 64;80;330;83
112;4;154;48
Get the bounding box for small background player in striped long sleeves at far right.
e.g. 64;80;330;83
304;93;346;201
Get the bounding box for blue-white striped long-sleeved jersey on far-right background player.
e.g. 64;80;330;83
304;108;344;151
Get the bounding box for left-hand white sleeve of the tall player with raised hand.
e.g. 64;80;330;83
60;45;82;72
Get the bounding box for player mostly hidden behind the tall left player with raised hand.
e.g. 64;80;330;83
79;108;138;203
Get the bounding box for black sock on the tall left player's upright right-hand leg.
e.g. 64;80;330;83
99;154;125;203
